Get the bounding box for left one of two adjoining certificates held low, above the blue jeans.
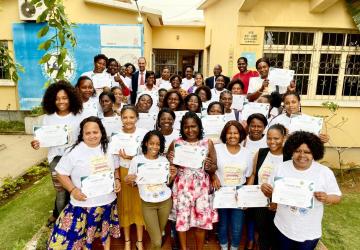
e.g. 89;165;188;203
213;187;238;208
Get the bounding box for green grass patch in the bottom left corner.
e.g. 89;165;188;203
0;175;55;250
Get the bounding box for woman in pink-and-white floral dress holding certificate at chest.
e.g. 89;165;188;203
168;111;217;250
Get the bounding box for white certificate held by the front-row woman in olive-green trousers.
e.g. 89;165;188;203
136;162;170;184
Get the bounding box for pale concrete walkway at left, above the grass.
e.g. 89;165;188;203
0;135;47;185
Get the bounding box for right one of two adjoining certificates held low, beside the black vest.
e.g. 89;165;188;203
237;185;269;207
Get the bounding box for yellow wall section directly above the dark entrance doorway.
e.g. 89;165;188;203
152;26;205;50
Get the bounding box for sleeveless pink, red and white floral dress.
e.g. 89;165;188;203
170;138;218;232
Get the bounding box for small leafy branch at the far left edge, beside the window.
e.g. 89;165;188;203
0;43;25;83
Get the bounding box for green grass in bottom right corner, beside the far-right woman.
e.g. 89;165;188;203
322;193;360;250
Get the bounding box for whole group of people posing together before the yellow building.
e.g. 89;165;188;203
31;57;341;250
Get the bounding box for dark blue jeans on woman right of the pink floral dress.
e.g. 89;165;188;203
218;208;244;247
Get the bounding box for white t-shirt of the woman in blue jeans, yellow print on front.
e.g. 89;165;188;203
215;143;252;186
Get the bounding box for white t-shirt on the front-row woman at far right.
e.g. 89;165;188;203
270;160;341;242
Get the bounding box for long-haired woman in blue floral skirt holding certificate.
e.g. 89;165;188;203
48;116;120;250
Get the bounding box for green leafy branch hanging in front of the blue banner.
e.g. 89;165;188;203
32;0;77;84
